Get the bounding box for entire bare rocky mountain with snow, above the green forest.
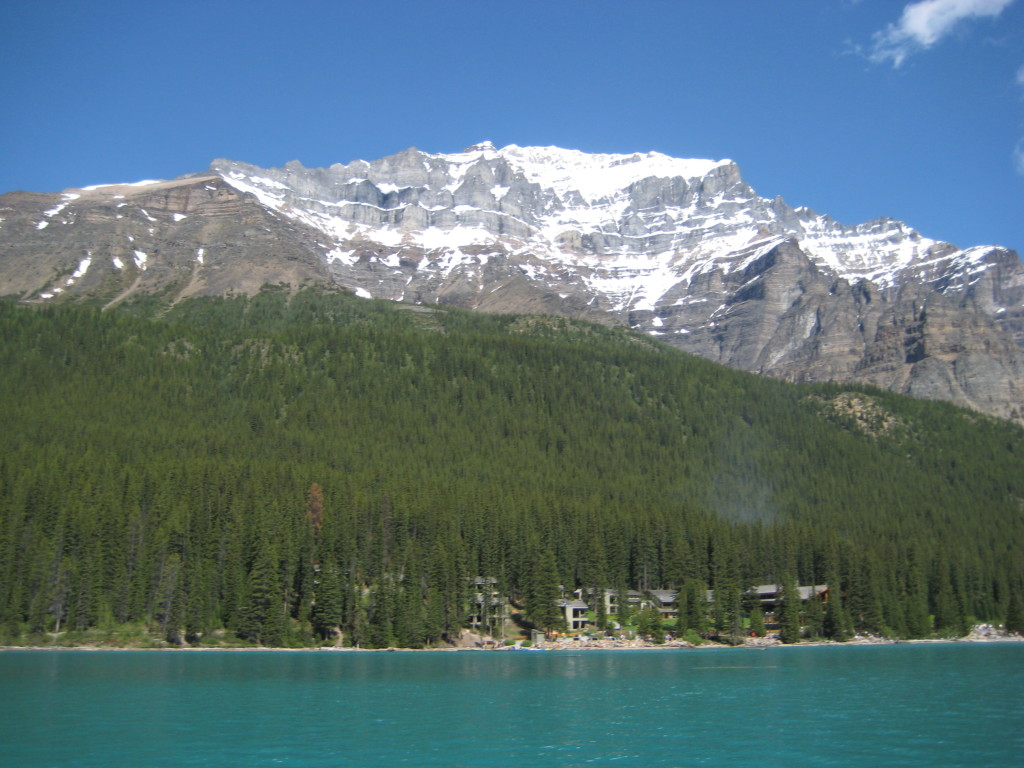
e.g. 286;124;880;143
0;144;1024;419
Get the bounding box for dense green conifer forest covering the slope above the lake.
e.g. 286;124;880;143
0;288;1024;647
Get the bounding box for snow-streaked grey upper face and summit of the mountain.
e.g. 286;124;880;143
211;142;1015;313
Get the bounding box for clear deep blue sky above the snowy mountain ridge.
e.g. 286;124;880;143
0;0;1024;252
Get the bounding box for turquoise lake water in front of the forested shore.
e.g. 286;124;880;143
0;643;1024;768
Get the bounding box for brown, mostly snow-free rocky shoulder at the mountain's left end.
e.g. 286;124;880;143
0;175;329;306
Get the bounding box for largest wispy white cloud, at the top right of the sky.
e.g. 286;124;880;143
868;0;1021;65
